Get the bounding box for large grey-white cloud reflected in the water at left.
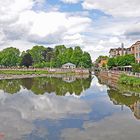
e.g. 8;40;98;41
0;90;91;140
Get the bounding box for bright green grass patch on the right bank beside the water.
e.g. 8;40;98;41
119;74;140;88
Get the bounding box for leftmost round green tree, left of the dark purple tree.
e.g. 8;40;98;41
0;47;20;66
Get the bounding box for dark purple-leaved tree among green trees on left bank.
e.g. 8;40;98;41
21;53;33;68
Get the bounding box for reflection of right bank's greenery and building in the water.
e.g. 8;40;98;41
99;77;140;119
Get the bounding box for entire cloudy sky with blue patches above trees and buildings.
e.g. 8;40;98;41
0;0;140;61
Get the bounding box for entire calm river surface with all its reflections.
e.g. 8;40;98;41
0;76;140;140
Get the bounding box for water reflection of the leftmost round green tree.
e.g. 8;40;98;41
0;80;21;94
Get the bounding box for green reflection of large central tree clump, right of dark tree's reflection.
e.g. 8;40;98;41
28;77;91;95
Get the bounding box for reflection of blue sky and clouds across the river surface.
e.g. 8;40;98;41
0;77;139;140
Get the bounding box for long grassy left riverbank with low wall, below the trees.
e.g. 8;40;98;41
0;69;89;80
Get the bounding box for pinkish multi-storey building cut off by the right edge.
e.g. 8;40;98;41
130;41;140;63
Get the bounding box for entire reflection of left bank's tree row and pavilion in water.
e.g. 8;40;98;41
0;75;92;95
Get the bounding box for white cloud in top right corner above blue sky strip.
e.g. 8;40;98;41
82;0;140;17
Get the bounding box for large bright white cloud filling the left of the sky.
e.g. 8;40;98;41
0;0;92;53
